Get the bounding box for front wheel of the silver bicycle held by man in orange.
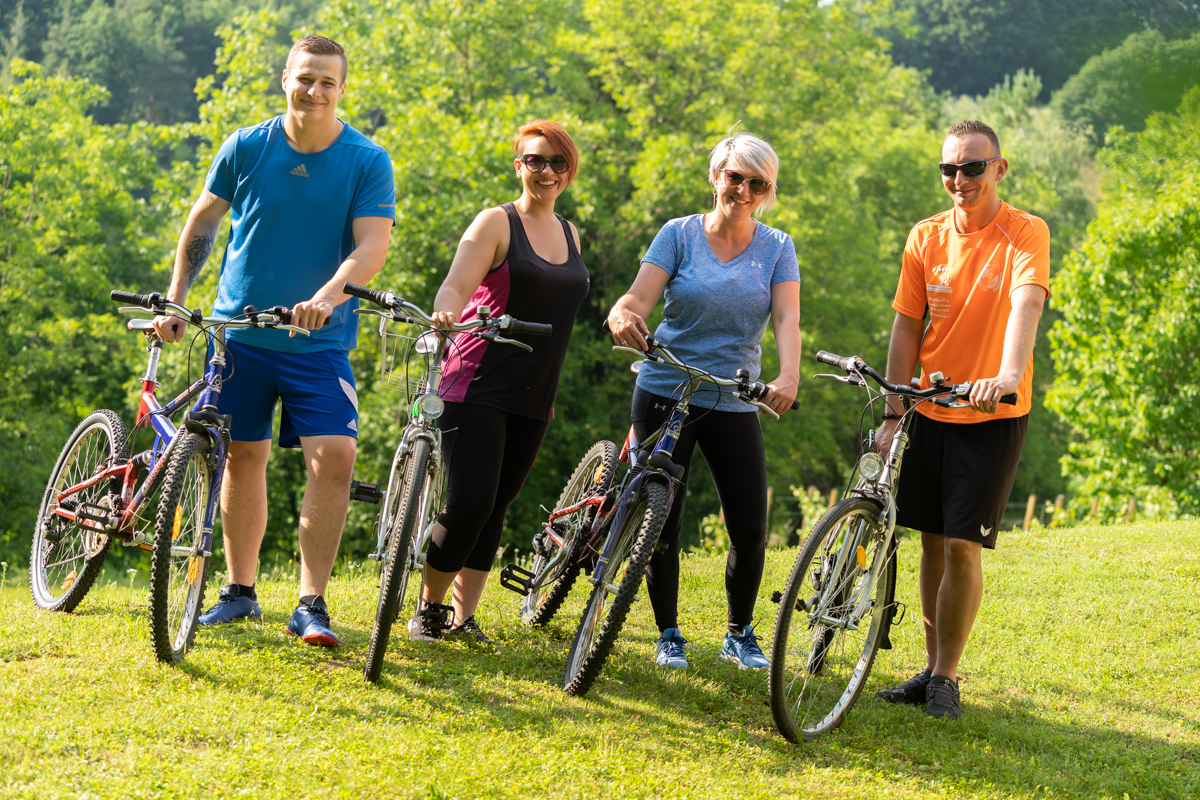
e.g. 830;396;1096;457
767;497;896;742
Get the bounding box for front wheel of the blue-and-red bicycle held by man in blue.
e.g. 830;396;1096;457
150;432;215;664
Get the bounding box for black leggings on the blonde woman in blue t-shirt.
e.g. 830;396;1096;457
632;389;767;631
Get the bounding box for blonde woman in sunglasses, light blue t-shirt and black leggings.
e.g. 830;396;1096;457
608;133;800;669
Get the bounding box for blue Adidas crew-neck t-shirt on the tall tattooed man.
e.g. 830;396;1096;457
204;116;396;353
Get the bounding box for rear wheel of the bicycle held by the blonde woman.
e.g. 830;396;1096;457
521;439;619;625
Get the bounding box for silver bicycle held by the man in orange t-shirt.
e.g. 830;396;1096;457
767;350;1016;742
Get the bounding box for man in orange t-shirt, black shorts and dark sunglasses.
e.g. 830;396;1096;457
877;120;1050;720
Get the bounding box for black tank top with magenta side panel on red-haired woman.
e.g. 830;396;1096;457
440;203;590;420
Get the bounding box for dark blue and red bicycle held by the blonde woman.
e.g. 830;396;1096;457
549;336;799;696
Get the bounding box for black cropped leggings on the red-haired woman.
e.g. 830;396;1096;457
427;403;550;572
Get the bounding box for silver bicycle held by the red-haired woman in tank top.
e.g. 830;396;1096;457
342;283;553;682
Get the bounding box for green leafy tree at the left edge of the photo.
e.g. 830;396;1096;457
0;61;173;563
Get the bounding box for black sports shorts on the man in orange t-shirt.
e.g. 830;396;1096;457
896;414;1030;549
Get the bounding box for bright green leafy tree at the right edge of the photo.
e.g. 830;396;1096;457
1048;90;1200;512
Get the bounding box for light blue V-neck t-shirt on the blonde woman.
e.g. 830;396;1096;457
637;213;800;411
